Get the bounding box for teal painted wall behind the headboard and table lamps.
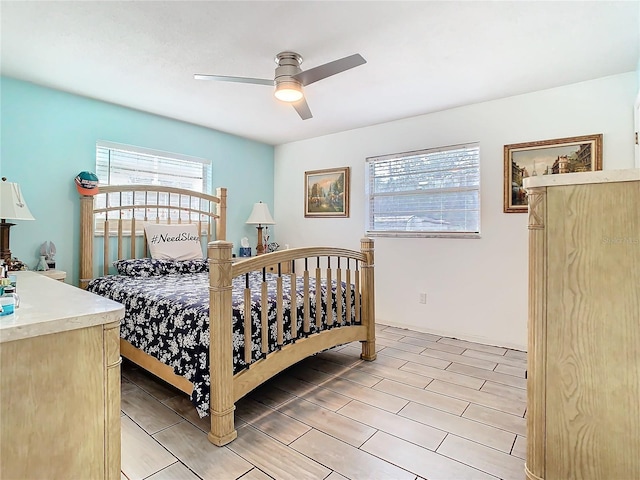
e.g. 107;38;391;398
0;77;276;285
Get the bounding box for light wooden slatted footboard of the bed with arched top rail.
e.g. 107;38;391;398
208;238;376;446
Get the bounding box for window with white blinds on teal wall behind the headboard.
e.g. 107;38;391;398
96;141;211;227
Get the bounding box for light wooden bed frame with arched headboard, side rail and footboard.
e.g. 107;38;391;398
80;185;376;445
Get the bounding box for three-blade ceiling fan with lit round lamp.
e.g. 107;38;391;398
193;52;367;120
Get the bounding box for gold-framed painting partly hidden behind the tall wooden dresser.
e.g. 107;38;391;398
504;133;602;213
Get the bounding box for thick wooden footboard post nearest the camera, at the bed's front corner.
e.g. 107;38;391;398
207;240;238;447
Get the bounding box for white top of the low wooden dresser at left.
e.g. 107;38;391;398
0;272;124;343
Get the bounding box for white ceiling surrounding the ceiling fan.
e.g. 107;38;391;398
0;0;640;145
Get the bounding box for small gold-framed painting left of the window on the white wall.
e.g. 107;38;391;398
304;167;350;218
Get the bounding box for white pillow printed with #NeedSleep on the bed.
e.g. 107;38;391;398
144;223;202;260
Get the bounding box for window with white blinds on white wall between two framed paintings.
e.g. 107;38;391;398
366;143;480;237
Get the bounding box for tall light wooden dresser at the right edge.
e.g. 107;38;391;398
524;169;640;480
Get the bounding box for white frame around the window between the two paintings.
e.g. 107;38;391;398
365;142;482;238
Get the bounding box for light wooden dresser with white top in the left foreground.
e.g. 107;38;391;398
0;272;124;480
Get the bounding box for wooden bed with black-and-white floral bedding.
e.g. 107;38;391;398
80;185;376;446
